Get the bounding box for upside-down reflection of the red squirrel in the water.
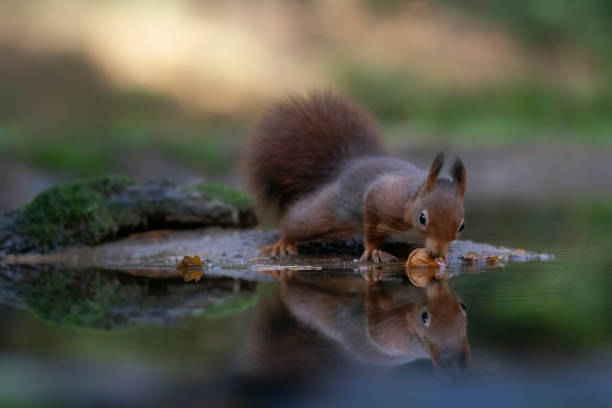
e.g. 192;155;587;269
249;271;470;377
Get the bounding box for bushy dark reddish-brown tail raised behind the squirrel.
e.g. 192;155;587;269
245;92;383;211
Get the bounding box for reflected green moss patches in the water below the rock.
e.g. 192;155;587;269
22;265;259;330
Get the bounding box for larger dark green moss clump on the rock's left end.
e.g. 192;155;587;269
21;176;134;247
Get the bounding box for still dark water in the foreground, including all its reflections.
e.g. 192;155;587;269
0;202;612;407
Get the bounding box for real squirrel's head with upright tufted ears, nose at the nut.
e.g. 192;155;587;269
406;153;466;258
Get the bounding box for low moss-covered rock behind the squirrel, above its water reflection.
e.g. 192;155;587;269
0;175;257;254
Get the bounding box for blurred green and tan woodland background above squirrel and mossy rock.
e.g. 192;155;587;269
0;0;612;214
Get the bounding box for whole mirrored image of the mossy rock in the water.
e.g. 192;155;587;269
18;265;259;330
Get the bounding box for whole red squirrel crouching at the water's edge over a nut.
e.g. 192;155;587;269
245;92;466;262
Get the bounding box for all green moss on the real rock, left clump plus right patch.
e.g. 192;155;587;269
13;176;256;250
